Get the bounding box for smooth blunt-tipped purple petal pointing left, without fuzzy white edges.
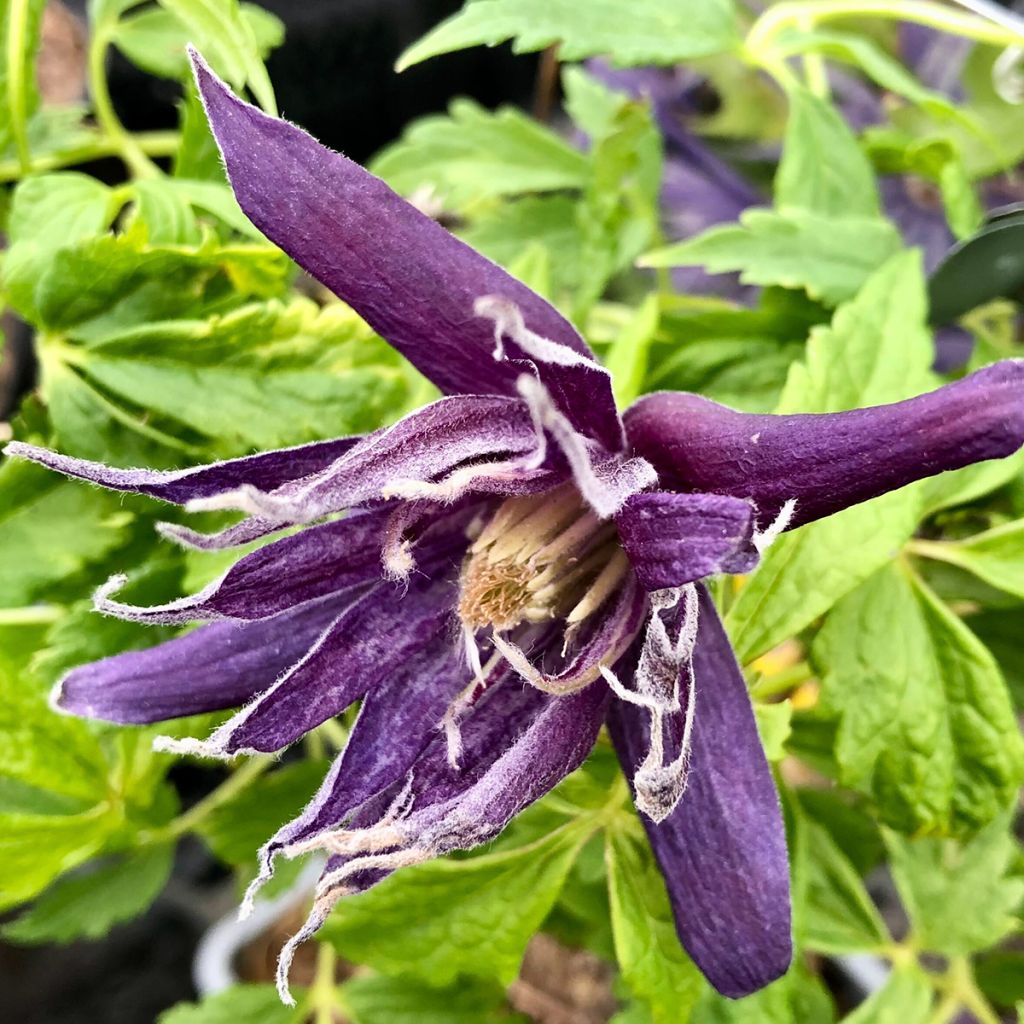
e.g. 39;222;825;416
54;598;352;725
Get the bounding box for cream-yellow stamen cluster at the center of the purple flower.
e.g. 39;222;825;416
459;484;629;633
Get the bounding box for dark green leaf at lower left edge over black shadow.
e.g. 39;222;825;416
0;846;174;945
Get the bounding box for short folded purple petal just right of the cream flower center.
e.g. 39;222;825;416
615;490;757;590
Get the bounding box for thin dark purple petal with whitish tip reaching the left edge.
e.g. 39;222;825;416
3;437;361;503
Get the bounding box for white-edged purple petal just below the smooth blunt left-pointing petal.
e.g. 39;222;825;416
169;559;457;757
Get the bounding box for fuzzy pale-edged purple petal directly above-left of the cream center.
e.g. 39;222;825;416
184;395;545;522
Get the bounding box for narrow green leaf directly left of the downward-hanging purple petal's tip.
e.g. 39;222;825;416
605;819;705;1024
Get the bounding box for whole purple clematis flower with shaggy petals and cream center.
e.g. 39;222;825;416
6;56;1024;997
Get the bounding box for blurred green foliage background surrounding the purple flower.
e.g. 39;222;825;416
0;0;1024;1024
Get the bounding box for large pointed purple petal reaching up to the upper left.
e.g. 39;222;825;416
193;55;622;451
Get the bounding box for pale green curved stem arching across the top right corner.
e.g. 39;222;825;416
744;0;1024;63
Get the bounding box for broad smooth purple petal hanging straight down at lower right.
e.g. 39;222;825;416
608;587;793;998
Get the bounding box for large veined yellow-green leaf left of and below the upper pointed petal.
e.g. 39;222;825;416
59;297;415;455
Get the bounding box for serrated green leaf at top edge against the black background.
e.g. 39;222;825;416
395;0;739;71
